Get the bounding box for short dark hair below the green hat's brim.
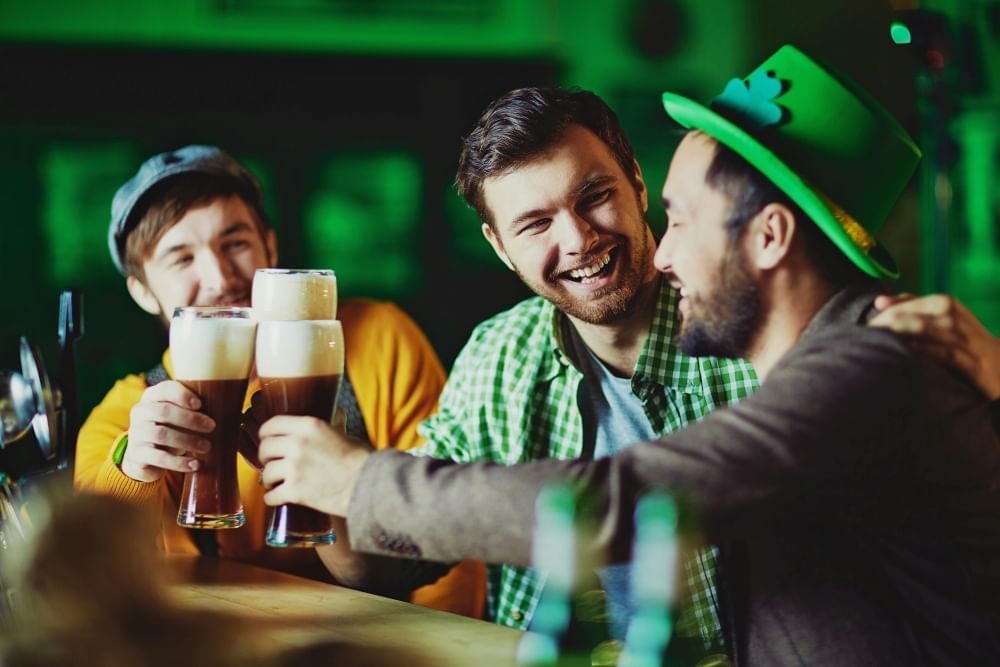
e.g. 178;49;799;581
705;139;877;287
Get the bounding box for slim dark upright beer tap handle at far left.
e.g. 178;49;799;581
59;289;83;468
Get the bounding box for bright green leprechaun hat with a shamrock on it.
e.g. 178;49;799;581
663;45;920;278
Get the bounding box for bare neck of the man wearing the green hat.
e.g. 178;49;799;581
746;270;836;382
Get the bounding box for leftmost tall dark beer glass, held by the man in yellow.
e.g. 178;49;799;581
170;307;256;528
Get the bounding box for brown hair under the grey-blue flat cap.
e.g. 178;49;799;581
122;172;269;283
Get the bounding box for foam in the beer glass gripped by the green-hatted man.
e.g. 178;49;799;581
257;320;344;378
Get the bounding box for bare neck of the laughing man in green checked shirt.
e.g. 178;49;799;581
566;274;660;377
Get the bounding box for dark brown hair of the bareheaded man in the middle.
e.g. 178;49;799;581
455;88;638;227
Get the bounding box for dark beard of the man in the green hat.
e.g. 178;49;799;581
677;247;763;359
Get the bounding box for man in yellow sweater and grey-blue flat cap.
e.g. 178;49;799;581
74;145;485;616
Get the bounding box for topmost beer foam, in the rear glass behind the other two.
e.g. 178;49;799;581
251;269;337;322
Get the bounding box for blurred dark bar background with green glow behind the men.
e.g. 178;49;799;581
0;0;1000;470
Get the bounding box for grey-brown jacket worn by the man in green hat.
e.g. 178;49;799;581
347;289;1000;665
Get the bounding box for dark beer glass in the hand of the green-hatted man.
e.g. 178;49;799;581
256;320;344;547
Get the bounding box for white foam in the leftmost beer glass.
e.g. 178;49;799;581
170;308;257;380
